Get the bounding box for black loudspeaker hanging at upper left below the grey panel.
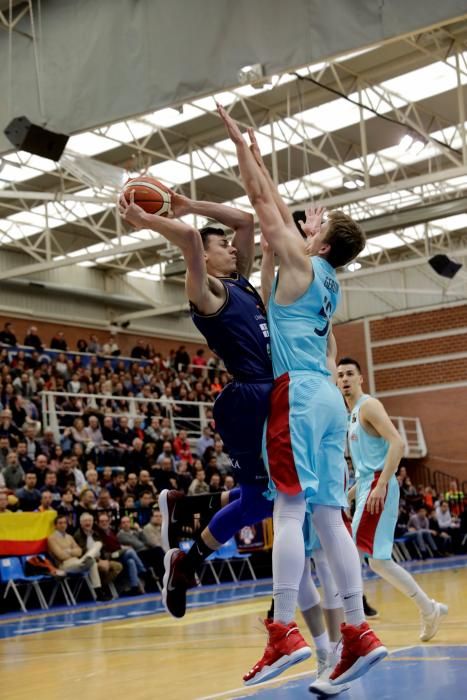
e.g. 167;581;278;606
3;117;69;161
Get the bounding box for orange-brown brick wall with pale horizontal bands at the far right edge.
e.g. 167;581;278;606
370;304;467;482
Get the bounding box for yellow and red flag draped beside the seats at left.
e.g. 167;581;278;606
0;510;57;557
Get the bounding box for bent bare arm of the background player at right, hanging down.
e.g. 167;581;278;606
360;398;404;513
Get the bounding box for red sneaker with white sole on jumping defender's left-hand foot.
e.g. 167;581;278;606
243;620;311;685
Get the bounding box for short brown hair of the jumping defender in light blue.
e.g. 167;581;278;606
325;209;366;268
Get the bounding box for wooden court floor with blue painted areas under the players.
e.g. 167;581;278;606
0;557;467;700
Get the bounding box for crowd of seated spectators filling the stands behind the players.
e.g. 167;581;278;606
0;323;467;597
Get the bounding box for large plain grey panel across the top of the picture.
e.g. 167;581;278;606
0;0;466;152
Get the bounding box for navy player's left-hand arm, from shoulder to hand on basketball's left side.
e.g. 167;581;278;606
118;192;223;313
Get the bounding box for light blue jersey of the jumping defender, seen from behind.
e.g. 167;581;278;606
268;256;340;377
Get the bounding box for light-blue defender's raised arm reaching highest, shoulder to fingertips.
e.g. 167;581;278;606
218;105;309;270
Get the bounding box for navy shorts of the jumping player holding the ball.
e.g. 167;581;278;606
214;380;273;488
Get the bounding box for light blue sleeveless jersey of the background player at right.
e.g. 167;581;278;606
348;394;389;480
